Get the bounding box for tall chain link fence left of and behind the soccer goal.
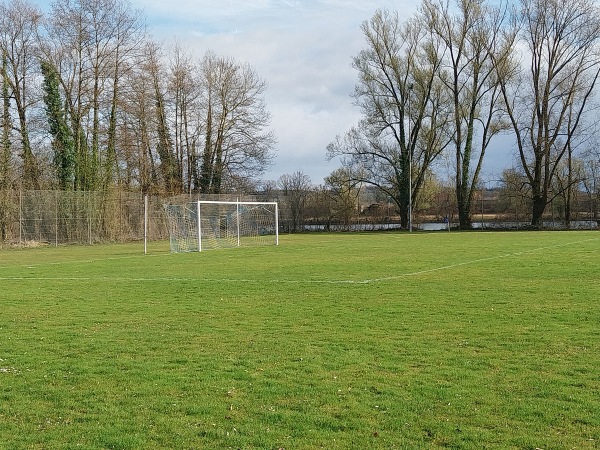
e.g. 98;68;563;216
0;190;262;247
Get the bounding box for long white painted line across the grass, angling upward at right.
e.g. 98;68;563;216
0;237;600;284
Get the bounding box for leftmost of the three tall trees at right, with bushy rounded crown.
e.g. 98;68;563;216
327;11;450;227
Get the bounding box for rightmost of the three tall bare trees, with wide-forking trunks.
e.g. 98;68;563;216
498;0;600;227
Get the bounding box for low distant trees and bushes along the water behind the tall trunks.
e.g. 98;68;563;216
274;167;600;232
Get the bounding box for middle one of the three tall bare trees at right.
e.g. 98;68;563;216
421;0;513;228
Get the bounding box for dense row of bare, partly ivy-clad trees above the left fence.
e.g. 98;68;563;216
0;0;275;198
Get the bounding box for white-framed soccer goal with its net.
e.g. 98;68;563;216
165;201;279;253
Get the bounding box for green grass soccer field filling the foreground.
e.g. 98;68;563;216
0;232;600;450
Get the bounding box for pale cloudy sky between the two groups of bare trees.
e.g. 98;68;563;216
38;0;510;185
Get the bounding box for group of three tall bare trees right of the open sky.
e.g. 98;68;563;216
327;0;600;228
